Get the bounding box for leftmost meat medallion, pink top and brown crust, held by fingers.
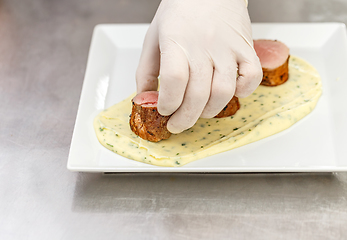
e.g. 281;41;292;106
129;91;171;142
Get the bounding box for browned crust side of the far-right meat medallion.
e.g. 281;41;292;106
261;56;290;87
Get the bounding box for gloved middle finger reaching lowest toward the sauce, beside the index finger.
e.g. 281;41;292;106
167;59;213;133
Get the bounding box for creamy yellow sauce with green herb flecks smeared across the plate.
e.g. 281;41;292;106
94;56;322;167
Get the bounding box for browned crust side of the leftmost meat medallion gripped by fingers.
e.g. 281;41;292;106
129;102;171;142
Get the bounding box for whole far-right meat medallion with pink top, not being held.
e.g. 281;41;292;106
254;39;289;86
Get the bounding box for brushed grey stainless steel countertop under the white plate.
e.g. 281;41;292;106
0;0;347;239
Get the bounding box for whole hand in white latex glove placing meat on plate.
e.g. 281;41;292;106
136;0;262;133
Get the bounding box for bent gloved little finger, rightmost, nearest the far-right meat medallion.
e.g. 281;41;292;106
235;52;263;98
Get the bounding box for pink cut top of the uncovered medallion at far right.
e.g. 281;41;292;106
254;40;289;69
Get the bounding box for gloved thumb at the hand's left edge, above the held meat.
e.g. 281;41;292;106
136;23;160;93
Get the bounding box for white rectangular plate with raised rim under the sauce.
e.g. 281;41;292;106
67;23;347;172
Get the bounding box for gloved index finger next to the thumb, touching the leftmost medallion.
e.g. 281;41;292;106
158;42;189;116
